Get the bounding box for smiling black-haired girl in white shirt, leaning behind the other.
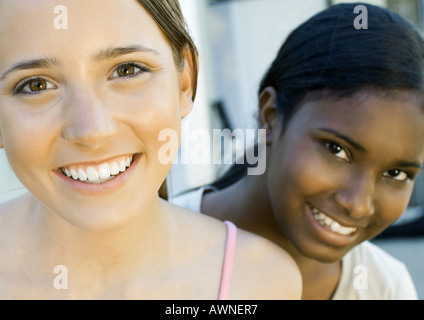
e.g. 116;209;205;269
173;4;424;299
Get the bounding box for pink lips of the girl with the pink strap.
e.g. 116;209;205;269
53;153;142;195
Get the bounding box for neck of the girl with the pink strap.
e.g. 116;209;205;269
26;192;172;278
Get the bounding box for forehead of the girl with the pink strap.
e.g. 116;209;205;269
0;0;169;68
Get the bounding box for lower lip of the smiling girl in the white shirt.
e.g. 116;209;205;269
306;204;360;247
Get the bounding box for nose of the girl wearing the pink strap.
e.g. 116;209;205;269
62;90;116;149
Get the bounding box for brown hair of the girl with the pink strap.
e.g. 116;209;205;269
138;0;199;199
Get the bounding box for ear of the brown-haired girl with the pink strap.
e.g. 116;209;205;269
180;48;197;118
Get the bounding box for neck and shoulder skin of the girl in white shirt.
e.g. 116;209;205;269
202;156;341;300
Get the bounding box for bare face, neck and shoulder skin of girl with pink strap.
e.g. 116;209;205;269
0;0;301;299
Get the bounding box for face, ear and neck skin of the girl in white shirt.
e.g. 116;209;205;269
202;87;424;299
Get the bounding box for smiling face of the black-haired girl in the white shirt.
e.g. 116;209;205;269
268;91;424;262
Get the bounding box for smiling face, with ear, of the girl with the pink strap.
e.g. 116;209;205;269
0;0;192;231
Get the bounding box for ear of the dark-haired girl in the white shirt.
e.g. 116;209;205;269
259;87;282;145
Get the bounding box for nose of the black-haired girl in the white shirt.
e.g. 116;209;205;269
334;172;375;219
